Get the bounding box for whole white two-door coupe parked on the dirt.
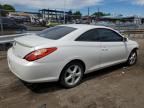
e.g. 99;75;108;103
7;24;139;88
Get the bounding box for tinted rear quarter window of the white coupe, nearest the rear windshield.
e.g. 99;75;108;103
76;29;99;42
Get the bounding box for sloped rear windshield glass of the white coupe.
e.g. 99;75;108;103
37;26;76;40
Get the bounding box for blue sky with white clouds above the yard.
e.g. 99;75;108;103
0;0;144;16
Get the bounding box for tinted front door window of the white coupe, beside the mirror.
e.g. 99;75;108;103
97;28;123;42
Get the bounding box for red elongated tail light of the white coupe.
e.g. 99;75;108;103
24;47;57;61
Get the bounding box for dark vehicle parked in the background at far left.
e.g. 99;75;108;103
0;17;27;34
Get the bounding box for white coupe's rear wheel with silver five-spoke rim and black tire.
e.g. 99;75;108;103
60;62;84;88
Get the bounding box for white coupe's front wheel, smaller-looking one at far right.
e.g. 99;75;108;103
127;50;137;66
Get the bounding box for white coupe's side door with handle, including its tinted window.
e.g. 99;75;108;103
97;28;127;67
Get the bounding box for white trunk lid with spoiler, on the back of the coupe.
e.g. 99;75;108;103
12;34;54;58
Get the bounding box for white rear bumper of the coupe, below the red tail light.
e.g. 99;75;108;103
7;49;64;83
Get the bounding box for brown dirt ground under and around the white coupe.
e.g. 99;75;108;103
0;39;144;108
